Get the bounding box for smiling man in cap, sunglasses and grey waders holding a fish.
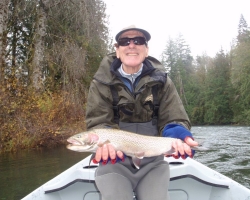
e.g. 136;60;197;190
86;26;197;200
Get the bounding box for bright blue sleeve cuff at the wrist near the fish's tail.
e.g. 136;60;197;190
162;124;193;141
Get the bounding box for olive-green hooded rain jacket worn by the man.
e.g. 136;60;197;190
86;53;190;135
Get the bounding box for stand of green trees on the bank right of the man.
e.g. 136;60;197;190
162;16;250;125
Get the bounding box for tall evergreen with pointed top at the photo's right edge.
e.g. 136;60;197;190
231;16;250;124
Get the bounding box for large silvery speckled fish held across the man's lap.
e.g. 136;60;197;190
67;128;203;168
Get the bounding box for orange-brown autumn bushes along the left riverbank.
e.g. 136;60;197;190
0;91;85;153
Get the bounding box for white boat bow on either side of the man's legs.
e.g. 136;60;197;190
23;156;250;200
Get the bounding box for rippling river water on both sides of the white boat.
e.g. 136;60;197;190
0;126;250;200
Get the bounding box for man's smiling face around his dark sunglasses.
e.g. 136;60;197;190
116;30;148;69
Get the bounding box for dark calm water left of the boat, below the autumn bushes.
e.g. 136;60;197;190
0;147;88;200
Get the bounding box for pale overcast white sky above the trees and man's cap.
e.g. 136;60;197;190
103;0;250;59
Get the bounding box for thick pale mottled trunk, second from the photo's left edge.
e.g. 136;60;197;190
31;0;49;91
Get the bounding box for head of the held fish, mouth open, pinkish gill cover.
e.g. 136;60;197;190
67;133;99;152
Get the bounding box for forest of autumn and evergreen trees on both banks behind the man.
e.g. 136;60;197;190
0;0;250;152
